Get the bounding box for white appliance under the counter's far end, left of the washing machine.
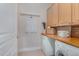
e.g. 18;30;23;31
42;35;55;56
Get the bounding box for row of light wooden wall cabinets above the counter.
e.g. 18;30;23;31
47;3;79;27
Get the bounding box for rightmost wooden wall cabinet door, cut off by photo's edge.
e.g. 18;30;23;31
72;3;79;25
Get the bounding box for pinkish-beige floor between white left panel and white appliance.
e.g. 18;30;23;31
18;50;45;56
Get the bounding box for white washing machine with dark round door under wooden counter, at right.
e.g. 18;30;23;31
55;40;79;56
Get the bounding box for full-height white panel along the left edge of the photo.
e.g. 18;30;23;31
0;3;17;56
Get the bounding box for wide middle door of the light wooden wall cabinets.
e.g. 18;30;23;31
58;3;71;26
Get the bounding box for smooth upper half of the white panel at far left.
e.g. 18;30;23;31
0;3;17;33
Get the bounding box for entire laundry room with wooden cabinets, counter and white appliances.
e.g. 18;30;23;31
0;2;79;56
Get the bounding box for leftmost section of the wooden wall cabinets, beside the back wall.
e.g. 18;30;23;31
47;4;58;27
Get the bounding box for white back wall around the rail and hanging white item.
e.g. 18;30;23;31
18;3;49;50
